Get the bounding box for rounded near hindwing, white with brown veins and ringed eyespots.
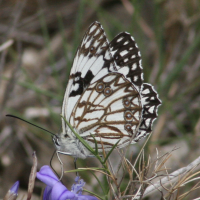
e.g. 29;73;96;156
70;73;142;149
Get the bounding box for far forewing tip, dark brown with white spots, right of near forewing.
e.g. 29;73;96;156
109;32;143;91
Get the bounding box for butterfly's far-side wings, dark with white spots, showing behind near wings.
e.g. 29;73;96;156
109;32;161;142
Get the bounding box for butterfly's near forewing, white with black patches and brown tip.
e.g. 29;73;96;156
62;22;115;136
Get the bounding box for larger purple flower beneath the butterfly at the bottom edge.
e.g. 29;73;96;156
37;165;98;200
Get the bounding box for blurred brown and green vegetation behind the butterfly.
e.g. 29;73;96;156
0;0;200;200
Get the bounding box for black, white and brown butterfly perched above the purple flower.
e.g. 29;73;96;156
53;22;161;159
